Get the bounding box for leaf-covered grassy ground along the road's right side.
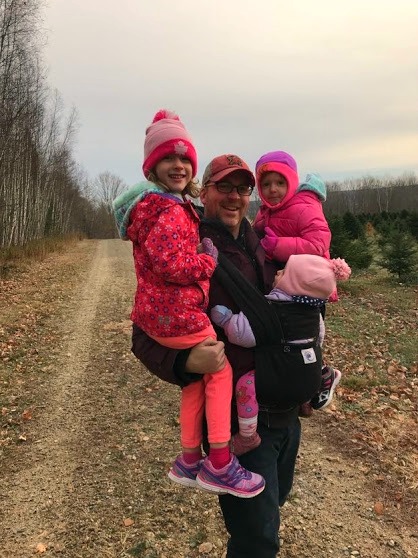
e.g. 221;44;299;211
322;270;418;521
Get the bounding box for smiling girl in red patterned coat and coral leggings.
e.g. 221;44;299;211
114;110;265;498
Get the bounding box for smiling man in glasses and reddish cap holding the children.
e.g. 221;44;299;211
132;155;300;558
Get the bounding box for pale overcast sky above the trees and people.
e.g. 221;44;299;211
44;0;418;184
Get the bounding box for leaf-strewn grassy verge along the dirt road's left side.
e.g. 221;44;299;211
0;238;95;457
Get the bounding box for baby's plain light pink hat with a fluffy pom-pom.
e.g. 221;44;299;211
274;254;351;300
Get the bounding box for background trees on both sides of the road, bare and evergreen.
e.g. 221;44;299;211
0;0;418;278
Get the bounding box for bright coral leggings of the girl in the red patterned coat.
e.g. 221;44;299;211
150;326;232;448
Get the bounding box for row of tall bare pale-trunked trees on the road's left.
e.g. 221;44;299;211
0;0;98;248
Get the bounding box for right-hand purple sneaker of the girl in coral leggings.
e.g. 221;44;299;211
196;455;266;498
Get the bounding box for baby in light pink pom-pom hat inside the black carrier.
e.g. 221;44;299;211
211;254;351;455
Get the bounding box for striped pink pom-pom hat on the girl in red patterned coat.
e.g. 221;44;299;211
142;109;197;178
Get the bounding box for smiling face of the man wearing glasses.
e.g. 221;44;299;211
200;170;250;238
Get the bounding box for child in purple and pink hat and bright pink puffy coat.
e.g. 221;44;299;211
253;151;341;416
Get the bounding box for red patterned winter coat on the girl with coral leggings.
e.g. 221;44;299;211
127;194;216;337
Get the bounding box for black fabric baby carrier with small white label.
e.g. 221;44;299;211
215;254;322;412
